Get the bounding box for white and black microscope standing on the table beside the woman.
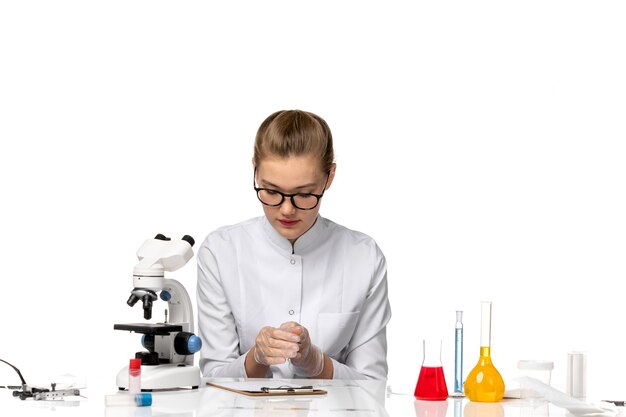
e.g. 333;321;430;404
113;234;202;391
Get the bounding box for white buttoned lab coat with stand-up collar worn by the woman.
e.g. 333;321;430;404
197;216;391;379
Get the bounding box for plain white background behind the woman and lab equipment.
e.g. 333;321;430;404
0;0;626;399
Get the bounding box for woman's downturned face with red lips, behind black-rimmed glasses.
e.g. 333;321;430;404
256;156;335;244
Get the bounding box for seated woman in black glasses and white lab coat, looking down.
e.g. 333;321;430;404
198;110;391;379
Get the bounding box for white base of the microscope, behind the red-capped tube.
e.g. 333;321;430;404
116;363;200;391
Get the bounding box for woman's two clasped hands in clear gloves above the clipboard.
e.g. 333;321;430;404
254;321;324;377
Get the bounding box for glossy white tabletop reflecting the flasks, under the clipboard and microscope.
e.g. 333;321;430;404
0;379;616;417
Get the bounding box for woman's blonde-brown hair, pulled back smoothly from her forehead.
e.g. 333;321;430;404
254;110;335;173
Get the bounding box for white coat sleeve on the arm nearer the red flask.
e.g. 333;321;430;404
333;245;391;379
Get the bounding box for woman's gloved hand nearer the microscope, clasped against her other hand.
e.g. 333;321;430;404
254;326;301;366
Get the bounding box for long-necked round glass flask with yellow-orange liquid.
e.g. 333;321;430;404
464;301;504;402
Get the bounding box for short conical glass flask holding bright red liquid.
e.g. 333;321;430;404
414;339;448;401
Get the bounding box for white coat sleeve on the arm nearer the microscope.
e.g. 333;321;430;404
197;236;246;378
